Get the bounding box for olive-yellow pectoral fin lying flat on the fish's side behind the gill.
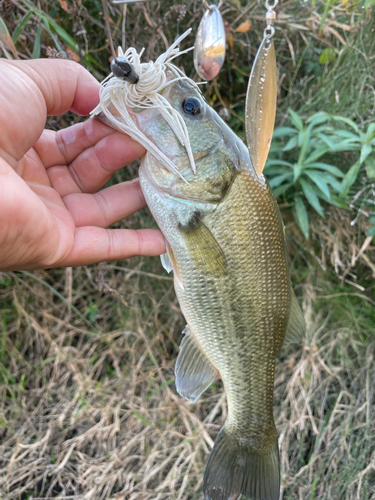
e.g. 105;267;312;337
178;212;227;276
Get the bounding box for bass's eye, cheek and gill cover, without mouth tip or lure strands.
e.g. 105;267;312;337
132;75;250;202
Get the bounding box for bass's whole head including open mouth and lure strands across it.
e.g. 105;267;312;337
94;69;251;202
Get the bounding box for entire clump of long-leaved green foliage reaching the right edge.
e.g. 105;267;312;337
265;110;375;238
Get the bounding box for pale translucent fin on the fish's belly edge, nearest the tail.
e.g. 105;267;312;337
175;326;217;402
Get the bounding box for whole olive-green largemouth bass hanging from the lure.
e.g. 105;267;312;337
93;37;304;500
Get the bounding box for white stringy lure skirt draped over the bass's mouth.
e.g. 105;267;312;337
91;29;206;182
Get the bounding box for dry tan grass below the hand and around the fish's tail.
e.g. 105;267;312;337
0;259;375;500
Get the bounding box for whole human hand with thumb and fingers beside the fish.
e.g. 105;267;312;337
0;59;165;270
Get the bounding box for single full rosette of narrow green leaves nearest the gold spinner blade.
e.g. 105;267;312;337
265;109;344;238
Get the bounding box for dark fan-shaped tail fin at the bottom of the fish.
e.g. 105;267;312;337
203;427;280;500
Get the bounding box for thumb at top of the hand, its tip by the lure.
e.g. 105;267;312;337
0;59;100;167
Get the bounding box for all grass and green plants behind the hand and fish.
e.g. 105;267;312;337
0;0;375;500
